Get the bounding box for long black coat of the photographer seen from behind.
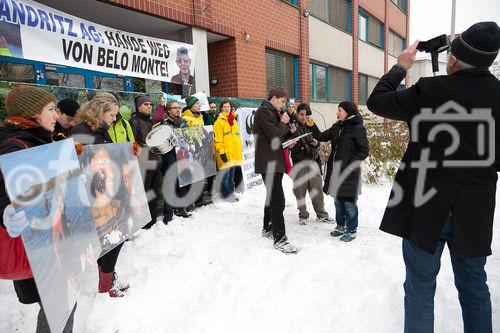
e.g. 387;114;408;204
367;66;500;257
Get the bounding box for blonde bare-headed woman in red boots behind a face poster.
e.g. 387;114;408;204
70;92;129;297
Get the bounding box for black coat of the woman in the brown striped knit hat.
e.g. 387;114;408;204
0;124;52;304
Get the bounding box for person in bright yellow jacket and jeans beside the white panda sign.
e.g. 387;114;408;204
214;101;242;202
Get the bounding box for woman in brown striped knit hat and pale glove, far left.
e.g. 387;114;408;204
0;86;76;332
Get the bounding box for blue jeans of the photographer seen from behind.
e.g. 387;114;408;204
403;217;492;333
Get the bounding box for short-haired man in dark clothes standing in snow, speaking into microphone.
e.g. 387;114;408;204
254;87;300;253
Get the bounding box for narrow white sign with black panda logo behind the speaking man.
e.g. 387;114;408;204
236;108;262;191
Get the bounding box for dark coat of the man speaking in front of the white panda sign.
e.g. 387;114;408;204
253;101;290;174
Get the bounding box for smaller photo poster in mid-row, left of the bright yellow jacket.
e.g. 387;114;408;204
174;125;217;187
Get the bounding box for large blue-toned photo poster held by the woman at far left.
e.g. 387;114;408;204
0;139;101;333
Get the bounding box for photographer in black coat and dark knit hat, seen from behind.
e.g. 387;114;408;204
367;22;500;332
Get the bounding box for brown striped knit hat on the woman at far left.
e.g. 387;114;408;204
4;86;56;119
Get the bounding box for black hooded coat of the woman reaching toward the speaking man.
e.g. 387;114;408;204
311;113;369;198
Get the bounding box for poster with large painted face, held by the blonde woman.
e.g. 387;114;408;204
78;142;151;256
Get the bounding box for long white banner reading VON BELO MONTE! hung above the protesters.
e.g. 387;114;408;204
0;0;195;84
